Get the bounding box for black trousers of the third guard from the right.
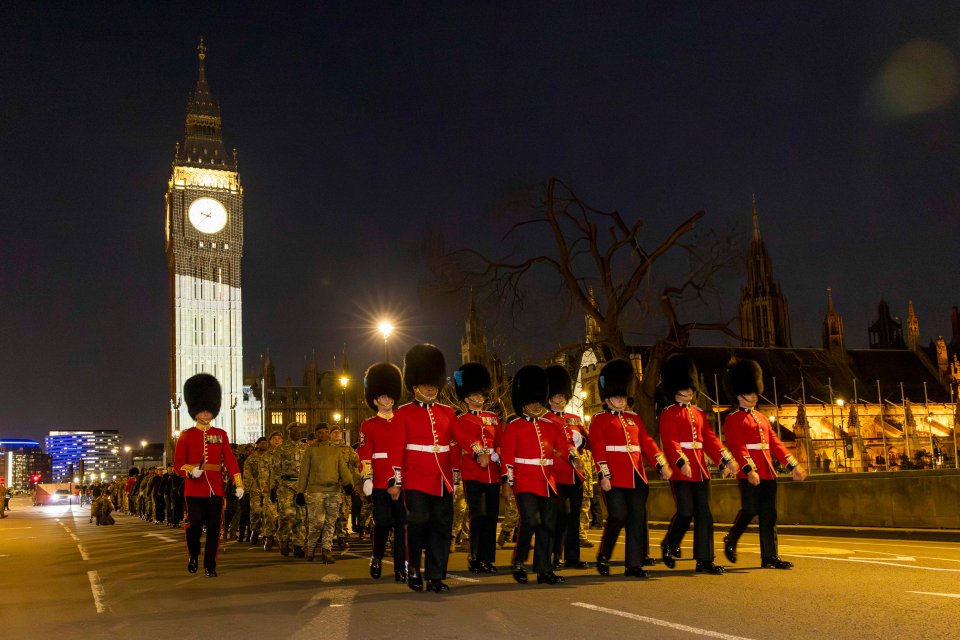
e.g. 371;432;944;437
597;474;650;568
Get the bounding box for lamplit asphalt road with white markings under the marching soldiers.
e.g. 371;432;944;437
0;498;960;640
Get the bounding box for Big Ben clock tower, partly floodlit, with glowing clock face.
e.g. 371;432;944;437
165;39;243;442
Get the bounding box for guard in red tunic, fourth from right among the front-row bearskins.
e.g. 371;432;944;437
500;365;580;584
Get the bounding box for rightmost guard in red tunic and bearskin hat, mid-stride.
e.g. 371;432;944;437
723;360;807;569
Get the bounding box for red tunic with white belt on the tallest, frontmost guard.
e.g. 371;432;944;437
388;402;457;496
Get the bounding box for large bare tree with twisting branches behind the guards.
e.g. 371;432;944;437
435;178;736;432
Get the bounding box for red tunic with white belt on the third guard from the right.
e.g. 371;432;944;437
590;411;666;489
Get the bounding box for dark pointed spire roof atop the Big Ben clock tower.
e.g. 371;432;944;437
175;38;236;171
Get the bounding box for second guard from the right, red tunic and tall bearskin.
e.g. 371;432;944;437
660;353;740;575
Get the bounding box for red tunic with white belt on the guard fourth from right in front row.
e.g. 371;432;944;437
500;416;570;497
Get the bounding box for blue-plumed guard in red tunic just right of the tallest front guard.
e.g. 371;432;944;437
453;362;501;573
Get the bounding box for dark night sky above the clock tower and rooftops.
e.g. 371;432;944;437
0;1;960;440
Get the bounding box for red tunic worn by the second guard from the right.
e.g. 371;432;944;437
660;404;730;482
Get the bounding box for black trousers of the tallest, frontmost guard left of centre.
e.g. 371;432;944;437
403;489;453;580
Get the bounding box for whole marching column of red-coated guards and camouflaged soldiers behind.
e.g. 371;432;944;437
109;344;806;593
